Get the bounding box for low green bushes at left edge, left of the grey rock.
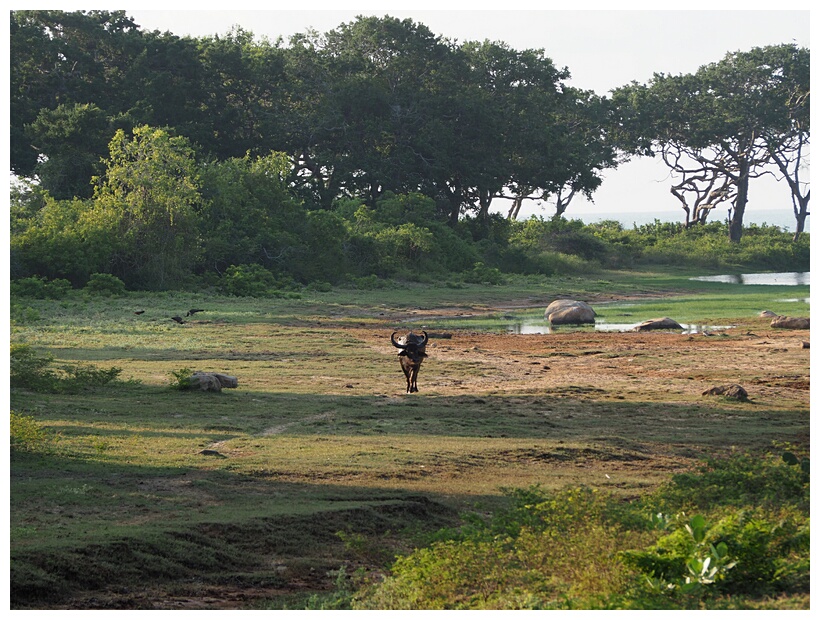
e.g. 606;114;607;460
10;344;122;393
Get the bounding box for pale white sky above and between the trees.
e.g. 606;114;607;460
4;0;810;219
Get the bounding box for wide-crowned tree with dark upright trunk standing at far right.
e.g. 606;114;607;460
613;45;808;242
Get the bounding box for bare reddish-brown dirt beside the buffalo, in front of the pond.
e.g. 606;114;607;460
358;320;809;407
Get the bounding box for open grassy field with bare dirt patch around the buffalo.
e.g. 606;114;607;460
10;273;809;609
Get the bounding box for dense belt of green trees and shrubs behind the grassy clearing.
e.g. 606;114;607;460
10;10;810;295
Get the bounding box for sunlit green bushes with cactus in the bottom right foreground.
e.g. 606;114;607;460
350;453;809;609
